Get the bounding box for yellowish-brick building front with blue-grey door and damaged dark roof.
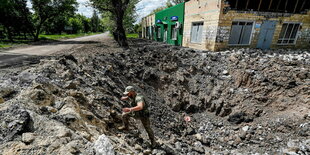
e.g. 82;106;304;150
214;0;310;51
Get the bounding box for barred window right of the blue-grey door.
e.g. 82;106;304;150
278;23;300;45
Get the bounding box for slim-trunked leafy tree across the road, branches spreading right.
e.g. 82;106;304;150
31;0;78;40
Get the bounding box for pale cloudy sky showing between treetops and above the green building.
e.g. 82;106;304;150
27;0;167;22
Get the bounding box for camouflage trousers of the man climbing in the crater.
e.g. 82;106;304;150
122;113;155;144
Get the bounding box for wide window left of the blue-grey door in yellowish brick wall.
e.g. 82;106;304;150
228;21;254;45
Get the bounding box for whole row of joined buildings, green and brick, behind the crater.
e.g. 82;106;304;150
142;0;310;51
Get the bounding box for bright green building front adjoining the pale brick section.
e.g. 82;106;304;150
154;3;185;46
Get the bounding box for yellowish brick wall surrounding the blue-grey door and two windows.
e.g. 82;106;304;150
214;0;310;51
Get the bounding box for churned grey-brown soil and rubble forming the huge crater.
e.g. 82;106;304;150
0;39;310;155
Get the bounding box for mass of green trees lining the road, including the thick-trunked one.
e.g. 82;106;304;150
0;0;139;43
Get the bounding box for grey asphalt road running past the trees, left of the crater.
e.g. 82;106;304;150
0;33;109;68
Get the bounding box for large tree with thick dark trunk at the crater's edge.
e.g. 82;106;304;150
90;0;138;48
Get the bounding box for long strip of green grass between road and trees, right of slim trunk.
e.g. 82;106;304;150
39;32;101;40
